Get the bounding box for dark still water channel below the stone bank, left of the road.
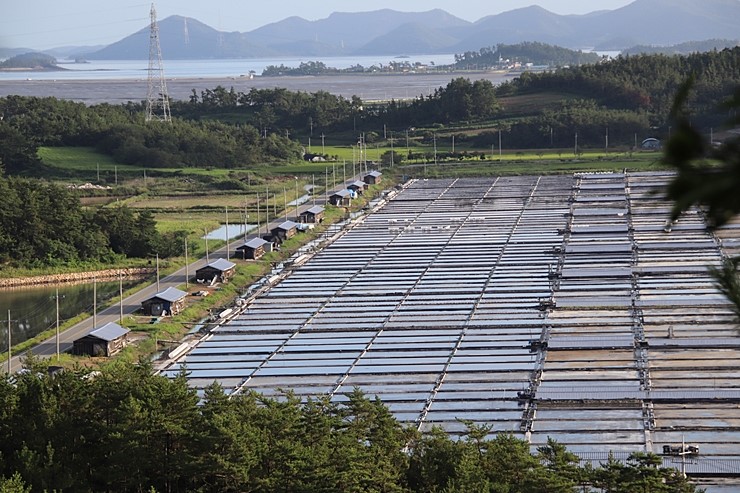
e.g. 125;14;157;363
0;279;140;352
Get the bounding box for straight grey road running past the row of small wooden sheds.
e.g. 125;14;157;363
0;184;360;373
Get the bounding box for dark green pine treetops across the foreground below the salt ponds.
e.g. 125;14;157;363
0;359;696;493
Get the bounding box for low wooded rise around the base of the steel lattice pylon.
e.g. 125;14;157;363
0;96;300;173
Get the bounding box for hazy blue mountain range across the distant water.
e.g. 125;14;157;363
47;0;740;60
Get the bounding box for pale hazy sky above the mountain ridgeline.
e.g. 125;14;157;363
0;0;632;49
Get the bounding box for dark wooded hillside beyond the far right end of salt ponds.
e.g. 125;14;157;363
486;47;740;152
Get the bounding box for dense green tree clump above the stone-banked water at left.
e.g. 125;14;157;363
0;177;185;267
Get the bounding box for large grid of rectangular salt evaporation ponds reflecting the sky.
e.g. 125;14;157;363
165;173;740;470
